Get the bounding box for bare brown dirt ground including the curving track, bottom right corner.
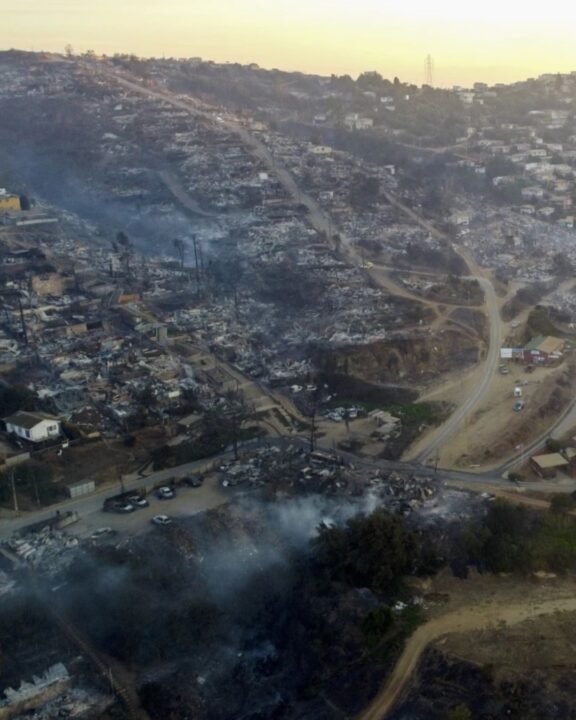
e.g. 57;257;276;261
361;573;576;720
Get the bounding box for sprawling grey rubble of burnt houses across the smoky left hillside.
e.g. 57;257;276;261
0;53;446;434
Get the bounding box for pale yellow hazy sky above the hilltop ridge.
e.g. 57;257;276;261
0;0;576;85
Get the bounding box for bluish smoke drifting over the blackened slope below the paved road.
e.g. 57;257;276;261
29;489;476;720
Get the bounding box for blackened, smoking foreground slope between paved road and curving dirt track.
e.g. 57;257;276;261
9;459;486;720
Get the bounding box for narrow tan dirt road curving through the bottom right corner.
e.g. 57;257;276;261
359;597;576;720
